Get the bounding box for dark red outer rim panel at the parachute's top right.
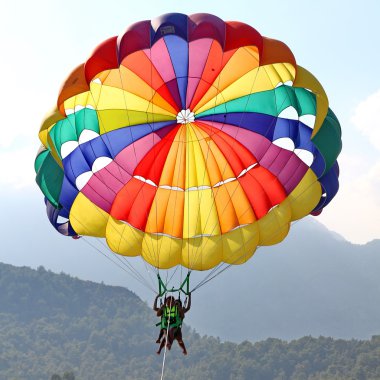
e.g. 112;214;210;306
224;21;263;54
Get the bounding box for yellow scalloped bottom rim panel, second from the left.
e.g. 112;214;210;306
106;216;144;256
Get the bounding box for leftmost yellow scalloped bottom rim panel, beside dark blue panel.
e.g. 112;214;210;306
69;193;109;237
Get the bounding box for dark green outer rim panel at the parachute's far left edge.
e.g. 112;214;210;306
36;151;63;208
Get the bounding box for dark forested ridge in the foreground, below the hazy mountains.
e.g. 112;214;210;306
0;264;380;380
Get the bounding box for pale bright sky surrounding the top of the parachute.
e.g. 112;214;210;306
0;0;380;247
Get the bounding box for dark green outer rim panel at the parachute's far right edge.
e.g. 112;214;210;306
312;109;342;173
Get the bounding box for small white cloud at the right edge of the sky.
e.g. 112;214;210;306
351;90;380;150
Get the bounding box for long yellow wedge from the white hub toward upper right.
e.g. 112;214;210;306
194;63;295;114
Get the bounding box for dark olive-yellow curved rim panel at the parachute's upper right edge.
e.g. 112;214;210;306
293;66;329;138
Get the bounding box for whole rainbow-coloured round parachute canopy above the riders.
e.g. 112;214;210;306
35;13;341;270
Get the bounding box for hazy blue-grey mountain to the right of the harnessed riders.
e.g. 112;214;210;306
189;219;380;341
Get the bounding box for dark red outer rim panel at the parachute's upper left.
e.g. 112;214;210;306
84;36;119;83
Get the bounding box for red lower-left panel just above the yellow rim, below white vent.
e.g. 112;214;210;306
110;178;157;230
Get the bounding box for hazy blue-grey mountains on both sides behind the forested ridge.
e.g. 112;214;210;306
0;191;380;342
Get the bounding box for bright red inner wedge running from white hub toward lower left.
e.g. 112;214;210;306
133;126;179;184
